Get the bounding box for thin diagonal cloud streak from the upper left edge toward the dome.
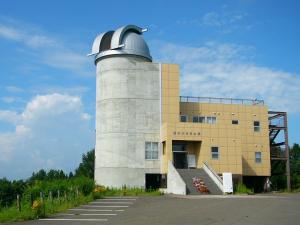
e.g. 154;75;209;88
0;21;94;76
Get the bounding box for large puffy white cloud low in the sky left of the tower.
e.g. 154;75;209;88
0;94;94;178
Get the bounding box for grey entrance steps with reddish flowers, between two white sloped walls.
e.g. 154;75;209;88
177;169;223;195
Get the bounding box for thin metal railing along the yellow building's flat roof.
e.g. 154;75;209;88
180;96;264;105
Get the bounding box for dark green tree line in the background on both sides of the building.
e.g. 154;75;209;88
0;144;300;206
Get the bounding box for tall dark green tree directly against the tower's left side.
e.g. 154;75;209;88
75;149;95;179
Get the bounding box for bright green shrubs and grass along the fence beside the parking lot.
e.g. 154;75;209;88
0;177;95;223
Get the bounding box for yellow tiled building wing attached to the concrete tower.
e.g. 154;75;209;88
161;64;271;192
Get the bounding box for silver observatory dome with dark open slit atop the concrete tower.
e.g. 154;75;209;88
91;25;152;62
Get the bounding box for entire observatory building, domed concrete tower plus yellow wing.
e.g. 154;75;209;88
92;25;271;192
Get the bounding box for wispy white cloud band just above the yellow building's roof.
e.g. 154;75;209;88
152;42;300;113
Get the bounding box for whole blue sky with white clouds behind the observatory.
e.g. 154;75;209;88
0;0;300;178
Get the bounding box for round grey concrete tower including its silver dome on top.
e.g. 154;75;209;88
92;25;160;187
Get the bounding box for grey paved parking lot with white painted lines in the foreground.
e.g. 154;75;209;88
5;195;300;225
